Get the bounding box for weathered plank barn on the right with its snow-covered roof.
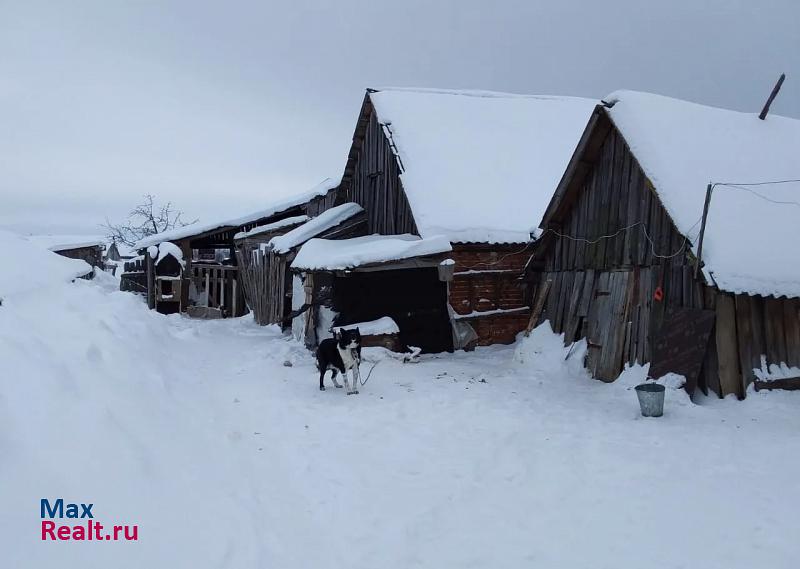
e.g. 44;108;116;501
529;91;800;397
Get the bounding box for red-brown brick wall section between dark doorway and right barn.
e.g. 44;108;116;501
449;243;530;346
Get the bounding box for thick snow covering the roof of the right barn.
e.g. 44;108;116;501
605;91;800;296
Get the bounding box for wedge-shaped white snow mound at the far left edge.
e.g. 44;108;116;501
0;230;92;299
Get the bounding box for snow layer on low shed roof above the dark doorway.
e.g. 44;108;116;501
292;234;453;271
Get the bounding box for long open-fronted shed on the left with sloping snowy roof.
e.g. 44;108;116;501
136;179;338;318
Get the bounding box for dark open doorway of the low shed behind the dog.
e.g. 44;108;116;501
333;268;453;353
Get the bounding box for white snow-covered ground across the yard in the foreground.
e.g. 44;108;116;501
0;268;800;569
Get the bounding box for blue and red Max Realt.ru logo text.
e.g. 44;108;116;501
40;498;139;541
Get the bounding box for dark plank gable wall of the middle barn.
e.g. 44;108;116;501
342;106;418;235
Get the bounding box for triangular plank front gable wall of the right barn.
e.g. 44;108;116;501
539;128;703;381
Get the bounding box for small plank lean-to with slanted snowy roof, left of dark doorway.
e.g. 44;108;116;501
234;203;366;328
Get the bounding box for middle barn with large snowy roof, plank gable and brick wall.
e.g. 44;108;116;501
324;89;596;349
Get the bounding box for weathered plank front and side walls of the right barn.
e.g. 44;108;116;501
539;120;800;397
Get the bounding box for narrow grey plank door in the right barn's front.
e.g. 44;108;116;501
586;271;632;381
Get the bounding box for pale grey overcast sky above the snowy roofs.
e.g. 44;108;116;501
0;0;800;233
